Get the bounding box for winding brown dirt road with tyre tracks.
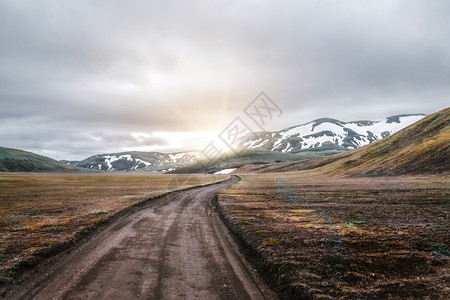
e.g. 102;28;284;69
7;177;274;299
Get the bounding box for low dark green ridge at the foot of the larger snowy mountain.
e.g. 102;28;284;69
171;149;342;174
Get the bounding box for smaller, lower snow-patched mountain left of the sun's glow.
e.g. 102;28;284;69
66;151;198;172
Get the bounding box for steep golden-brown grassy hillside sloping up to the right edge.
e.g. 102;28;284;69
248;108;450;176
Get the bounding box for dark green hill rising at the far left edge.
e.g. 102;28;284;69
0;147;78;172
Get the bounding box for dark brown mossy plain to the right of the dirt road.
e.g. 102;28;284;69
219;172;450;299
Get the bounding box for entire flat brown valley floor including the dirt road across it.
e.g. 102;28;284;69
0;172;450;299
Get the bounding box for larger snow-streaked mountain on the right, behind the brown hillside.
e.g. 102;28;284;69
235;114;425;153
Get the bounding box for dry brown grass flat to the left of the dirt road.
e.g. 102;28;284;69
0;173;224;283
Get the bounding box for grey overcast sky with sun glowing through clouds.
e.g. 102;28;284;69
0;0;450;159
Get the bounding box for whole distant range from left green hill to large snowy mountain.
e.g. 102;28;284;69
0;114;425;172
